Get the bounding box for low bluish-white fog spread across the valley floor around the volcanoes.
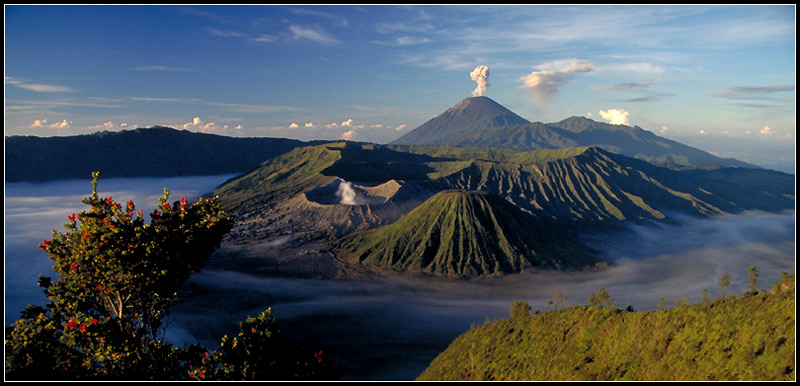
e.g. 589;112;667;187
5;176;795;380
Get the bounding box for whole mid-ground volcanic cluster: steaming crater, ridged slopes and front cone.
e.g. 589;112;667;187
215;142;794;277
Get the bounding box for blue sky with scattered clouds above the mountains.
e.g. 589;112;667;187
4;5;796;172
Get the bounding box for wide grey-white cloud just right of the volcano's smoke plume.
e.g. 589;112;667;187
520;59;595;105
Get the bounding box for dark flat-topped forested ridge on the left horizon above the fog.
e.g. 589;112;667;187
4;127;322;182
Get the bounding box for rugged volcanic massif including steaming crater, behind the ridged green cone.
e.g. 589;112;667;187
216;143;794;244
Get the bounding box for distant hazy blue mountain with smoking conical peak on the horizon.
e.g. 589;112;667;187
391;96;759;168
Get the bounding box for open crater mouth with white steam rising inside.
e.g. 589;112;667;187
305;178;401;205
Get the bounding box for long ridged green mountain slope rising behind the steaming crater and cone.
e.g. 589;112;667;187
217;143;794;225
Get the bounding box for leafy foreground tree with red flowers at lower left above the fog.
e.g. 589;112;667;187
5;173;344;380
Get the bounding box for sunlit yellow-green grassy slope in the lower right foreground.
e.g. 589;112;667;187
419;275;795;381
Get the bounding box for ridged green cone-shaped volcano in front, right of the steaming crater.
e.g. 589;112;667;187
334;191;597;277
